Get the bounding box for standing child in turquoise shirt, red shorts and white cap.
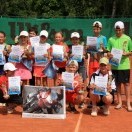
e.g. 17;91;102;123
87;21;107;76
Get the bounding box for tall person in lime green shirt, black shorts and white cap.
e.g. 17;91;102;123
107;21;132;111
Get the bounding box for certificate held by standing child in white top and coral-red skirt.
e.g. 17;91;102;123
34;46;48;65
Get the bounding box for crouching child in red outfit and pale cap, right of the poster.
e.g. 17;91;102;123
58;60;84;112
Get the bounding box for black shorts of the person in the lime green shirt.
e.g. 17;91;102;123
112;70;130;84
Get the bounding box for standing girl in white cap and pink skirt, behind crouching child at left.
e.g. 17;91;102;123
15;31;33;85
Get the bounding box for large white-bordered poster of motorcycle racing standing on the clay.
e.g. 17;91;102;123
22;85;66;119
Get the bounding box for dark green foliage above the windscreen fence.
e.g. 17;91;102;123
0;0;132;18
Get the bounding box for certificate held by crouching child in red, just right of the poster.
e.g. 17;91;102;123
62;72;74;90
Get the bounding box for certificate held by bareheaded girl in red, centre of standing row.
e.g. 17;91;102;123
52;44;64;61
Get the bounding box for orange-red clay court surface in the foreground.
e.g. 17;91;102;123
0;95;132;132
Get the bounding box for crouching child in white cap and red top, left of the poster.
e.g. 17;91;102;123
0;62;22;114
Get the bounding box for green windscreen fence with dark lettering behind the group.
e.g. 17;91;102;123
0;18;132;44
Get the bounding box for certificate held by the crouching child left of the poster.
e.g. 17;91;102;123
8;76;21;95
